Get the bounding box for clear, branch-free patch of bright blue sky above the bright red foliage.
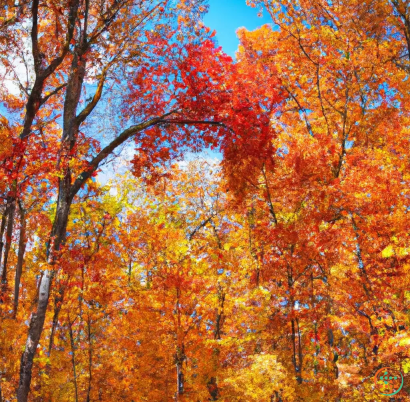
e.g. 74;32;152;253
204;0;272;57
